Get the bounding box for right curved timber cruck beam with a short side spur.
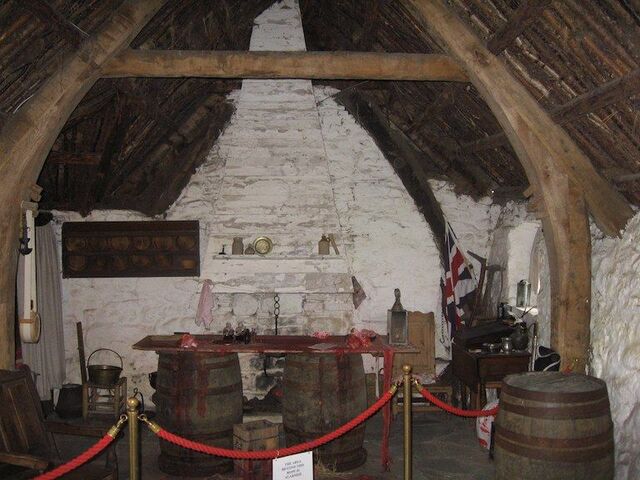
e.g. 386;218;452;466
403;0;633;371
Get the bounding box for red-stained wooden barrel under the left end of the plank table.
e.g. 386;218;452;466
154;352;242;476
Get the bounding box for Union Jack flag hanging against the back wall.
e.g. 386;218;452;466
442;222;478;338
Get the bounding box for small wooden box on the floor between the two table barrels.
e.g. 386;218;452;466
233;420;280;480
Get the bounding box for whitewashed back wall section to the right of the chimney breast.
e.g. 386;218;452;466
315;87;493;356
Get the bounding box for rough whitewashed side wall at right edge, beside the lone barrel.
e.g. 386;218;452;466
591;214;640;480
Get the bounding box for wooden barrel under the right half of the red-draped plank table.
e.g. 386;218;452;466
282;354;367;471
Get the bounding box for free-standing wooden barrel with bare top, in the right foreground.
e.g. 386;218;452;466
495;372;613;480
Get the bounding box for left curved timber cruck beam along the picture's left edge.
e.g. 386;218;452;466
0;0;166;368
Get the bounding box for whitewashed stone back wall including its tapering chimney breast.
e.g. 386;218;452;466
56;0;497;400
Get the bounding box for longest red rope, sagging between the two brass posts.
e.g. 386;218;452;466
152;388;395;460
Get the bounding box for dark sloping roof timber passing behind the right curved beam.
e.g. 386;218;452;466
460;68;640;153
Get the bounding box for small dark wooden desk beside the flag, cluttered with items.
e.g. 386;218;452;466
451;342;531;409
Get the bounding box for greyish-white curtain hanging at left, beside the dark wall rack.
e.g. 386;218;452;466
22;223;65;399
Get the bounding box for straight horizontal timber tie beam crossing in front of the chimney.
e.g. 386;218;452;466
103;50;468;82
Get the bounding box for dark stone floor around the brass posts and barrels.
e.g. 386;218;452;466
56;413;494;480
